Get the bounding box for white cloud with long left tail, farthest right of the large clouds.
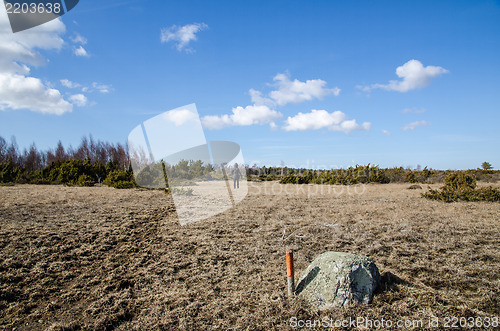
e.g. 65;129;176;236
358;60;449;92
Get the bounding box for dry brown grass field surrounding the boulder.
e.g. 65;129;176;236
0;182;500;330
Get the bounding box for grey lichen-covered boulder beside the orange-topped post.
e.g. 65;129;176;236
296;252;380;310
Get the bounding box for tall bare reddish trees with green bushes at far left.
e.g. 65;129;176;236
0;136;135;187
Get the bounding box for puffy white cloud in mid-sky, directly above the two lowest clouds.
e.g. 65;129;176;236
268;73;340;106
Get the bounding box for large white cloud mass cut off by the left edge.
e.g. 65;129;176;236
0;11;73;115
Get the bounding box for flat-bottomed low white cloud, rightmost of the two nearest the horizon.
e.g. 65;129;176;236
283;109;371;134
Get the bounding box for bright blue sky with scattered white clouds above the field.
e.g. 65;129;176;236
0;0;500;169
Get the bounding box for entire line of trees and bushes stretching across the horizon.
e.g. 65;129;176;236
0;136;500;195
